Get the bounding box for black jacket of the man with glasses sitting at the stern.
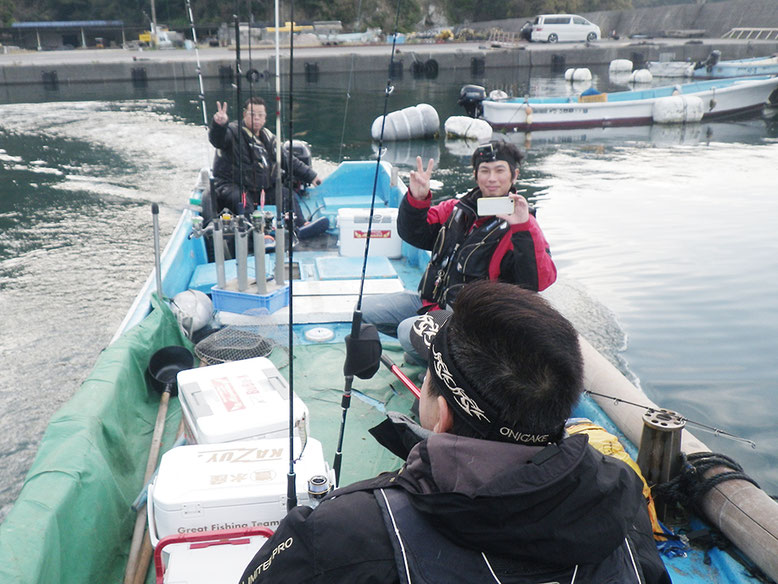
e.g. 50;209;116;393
208;121;316;212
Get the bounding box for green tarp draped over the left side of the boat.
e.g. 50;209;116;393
0;298;191;584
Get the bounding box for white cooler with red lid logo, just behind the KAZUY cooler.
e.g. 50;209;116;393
177;357;309;444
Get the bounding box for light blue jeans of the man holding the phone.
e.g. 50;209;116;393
362;291;427;363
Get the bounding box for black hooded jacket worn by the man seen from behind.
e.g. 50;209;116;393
235;434;670;584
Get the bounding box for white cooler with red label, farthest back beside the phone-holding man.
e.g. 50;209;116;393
338;207;402;258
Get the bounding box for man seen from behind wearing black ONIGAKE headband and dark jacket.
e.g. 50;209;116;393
236;281;670;584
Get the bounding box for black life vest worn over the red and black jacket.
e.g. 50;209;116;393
419;188;509;307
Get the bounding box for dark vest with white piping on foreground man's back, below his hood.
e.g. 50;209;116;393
373;488;645;584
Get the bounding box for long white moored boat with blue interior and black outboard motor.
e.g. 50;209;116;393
466;77;778;131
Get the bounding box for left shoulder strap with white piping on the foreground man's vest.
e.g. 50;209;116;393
373;489;500;584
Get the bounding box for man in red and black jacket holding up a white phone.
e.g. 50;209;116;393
362;140;556;358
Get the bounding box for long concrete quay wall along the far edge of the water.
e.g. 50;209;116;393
0;37;778;86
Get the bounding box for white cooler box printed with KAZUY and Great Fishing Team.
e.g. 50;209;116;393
147;438;334;547
